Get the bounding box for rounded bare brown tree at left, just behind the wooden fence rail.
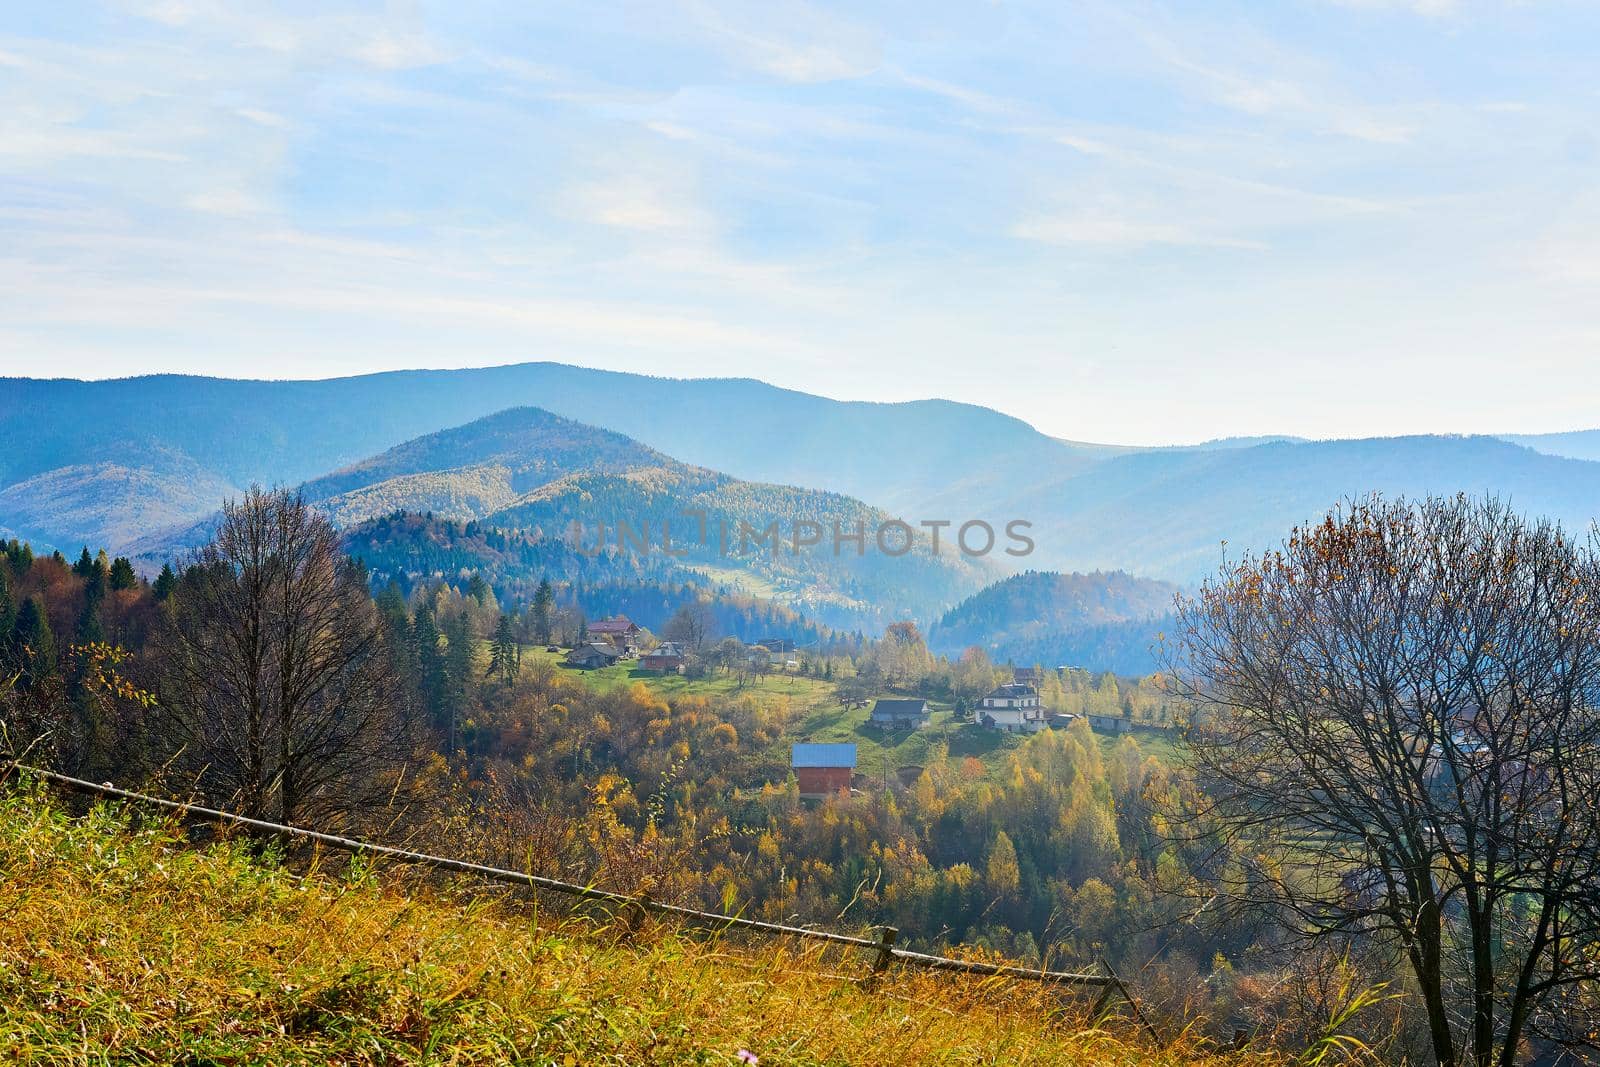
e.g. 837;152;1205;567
162;486;408;822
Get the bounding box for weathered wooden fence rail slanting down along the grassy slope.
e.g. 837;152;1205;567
0;763;1157;1037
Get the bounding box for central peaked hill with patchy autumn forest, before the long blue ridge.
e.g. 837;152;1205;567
292;408;994;625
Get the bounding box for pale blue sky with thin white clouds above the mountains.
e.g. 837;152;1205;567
0;0;1600;443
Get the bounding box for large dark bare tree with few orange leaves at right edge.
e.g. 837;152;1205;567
1176;498;1600;1067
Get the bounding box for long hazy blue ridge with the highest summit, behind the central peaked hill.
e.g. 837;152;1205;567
0;363;1109;541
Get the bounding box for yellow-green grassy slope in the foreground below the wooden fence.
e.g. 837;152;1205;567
0;790;1269;1067
